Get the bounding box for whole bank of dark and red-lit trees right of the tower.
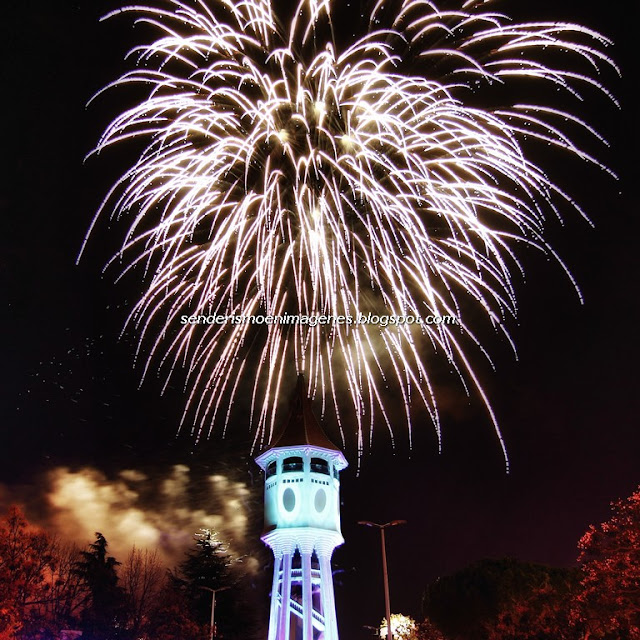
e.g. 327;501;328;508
423;487;640;640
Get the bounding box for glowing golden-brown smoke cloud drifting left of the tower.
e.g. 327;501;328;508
0;465;257;571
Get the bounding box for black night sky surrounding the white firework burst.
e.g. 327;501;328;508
0;0;640;637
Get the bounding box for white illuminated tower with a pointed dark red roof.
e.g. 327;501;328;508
256;376;347;640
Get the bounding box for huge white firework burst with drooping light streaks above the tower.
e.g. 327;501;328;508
79;0;615;459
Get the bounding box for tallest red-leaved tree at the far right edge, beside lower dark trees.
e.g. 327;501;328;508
573;487;640;640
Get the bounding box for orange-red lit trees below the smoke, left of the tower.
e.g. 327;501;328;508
0;507;244;640
